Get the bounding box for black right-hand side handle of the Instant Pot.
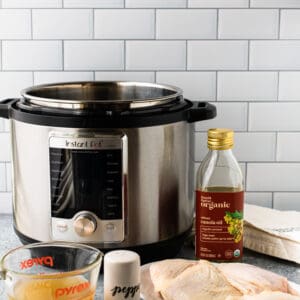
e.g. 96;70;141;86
187;101;217;123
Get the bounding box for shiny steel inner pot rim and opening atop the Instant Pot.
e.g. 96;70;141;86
21;81;182;110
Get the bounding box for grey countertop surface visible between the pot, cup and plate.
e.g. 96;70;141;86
0;215;300;299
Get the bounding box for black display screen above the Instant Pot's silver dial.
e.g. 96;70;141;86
50;148;123;220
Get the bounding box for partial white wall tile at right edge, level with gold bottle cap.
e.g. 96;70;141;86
277;132;300;162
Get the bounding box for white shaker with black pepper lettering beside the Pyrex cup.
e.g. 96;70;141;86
104;250;141;300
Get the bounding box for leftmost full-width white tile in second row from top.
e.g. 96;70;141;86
32;9;93;39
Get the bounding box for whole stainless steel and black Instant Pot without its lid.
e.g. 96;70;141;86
0;81;216;261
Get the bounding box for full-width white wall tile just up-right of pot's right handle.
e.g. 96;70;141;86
218;72;278;101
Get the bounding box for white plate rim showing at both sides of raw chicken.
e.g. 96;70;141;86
141;263;300;300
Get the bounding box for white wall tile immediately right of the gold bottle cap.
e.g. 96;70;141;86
234;132;276;162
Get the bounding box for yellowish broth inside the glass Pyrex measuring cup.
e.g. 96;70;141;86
8;276;95;300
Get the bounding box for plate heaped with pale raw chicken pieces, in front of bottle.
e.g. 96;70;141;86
141;259;300;300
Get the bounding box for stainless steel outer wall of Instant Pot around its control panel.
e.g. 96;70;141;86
10;119;194;249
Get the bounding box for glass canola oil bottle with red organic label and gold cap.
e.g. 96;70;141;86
195;128;244;261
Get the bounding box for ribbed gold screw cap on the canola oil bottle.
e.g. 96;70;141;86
207;128;234;150
